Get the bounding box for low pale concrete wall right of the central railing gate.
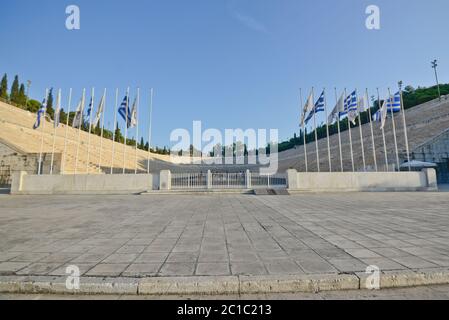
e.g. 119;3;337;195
287;169;438;192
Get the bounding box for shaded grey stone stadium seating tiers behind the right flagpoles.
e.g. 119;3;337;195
279;97;449;172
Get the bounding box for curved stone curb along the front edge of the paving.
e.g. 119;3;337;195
0;269;449;296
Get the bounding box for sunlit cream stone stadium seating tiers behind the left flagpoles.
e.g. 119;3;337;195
0;102;170;174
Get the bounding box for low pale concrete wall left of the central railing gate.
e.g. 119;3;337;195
11;171;153;194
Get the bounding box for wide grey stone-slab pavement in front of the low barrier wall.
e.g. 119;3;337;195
0;193;449;278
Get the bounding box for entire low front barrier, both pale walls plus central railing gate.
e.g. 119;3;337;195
11;169;438;195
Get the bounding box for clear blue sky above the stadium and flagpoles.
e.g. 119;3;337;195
0;0;449;146
